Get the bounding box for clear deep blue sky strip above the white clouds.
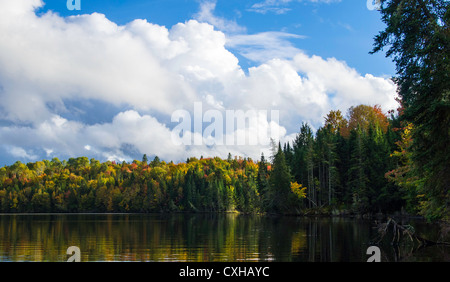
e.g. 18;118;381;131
41;0;395;76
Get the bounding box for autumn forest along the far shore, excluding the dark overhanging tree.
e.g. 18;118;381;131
0;105;425;218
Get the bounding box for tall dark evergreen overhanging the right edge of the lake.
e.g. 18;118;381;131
372;0;450;219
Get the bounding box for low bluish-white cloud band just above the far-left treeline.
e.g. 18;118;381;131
0;110;286;164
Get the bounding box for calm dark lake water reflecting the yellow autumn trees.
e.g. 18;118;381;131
0;214;450;262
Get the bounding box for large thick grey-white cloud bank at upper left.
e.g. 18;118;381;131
0;4;193;122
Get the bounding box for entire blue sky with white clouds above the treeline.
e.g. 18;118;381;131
0;0;397;165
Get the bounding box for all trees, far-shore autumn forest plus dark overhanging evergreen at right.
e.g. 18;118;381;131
0;0;450;224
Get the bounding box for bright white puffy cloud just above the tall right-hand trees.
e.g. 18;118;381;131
222;52;398;133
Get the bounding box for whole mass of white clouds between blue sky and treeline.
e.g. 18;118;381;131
0;0;396;162
